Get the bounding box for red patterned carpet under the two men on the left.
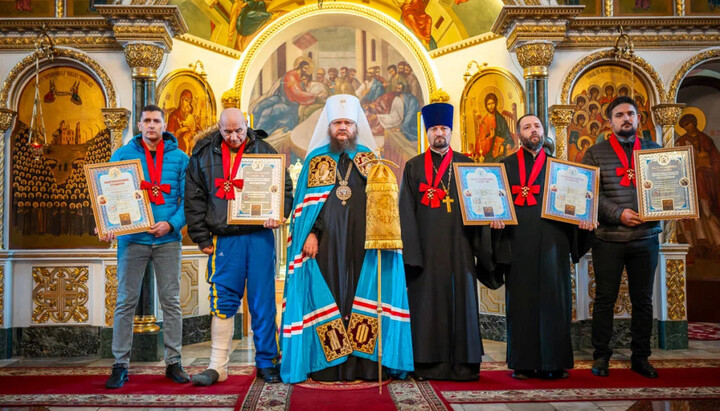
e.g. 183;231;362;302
0;367;255;407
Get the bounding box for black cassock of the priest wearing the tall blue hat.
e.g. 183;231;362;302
400;152;509;380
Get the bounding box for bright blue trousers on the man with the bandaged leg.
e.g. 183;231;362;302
207;230;278;368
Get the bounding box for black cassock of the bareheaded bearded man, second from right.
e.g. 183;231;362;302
502;148;591;371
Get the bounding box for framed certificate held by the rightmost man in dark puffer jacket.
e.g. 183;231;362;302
635;146;699;221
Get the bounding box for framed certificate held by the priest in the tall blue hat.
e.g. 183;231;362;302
453;163;517;225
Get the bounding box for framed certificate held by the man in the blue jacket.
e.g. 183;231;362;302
85;160;155;237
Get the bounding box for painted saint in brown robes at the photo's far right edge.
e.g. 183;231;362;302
675;114;720;263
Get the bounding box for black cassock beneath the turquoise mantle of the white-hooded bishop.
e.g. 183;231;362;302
311;153;378;381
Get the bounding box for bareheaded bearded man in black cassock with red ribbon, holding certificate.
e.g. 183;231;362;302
490;114;595;380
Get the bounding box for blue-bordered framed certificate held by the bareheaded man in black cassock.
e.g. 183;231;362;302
541;158;600;224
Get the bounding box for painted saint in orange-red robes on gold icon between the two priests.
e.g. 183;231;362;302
475;93;513;163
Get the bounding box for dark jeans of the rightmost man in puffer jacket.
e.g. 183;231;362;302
592;236;659;360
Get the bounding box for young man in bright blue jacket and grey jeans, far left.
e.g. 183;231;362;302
101;105;190;388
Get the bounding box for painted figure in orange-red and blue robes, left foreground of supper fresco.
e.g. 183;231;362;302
250;57;318;134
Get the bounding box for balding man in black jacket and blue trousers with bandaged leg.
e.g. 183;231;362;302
185;108;292;385
